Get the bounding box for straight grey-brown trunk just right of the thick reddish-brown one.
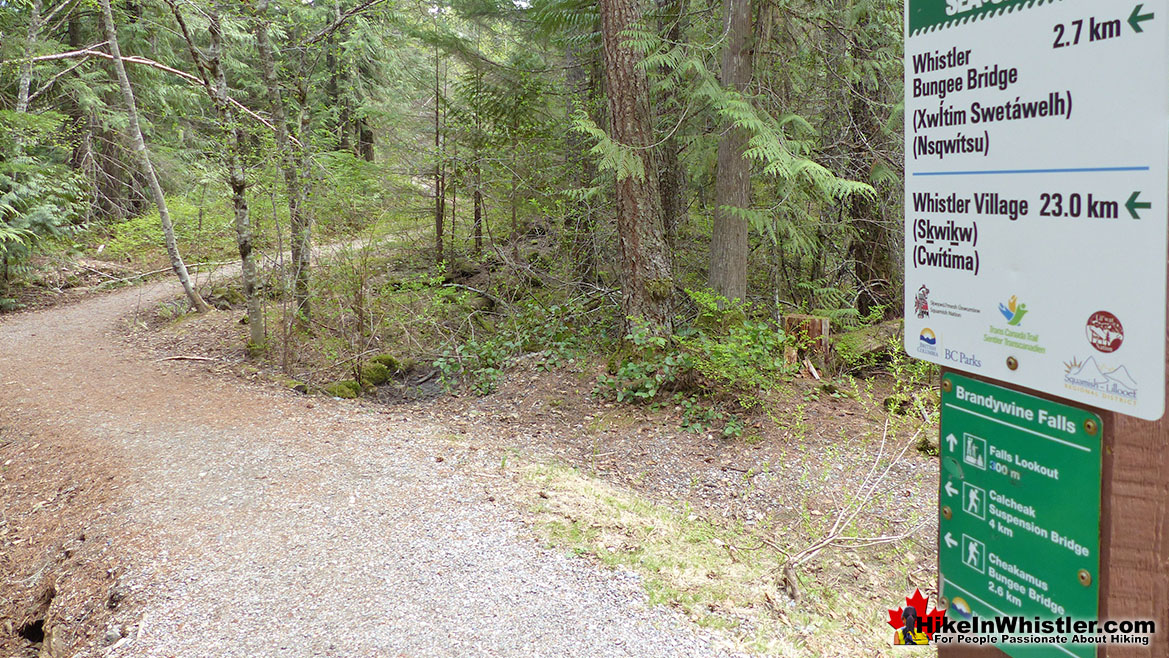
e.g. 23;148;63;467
710;0;752;299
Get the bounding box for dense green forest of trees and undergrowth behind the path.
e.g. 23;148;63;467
0;0;902;400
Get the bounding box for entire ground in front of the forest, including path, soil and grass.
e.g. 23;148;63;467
0;271;936;657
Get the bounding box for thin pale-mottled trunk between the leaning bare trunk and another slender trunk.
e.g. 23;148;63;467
205;8;265;348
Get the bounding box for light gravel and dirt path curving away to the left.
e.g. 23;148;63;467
0;279;718;657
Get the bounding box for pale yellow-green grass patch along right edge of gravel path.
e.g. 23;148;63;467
521;465;907;657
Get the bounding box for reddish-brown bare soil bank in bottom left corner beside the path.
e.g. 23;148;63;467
0;417;136;657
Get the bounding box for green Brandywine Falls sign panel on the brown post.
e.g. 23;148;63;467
938;373;1102;657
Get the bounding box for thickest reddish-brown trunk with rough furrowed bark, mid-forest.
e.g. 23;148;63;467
601;0;673;335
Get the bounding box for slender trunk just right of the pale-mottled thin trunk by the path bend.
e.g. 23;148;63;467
254;0;312;320
